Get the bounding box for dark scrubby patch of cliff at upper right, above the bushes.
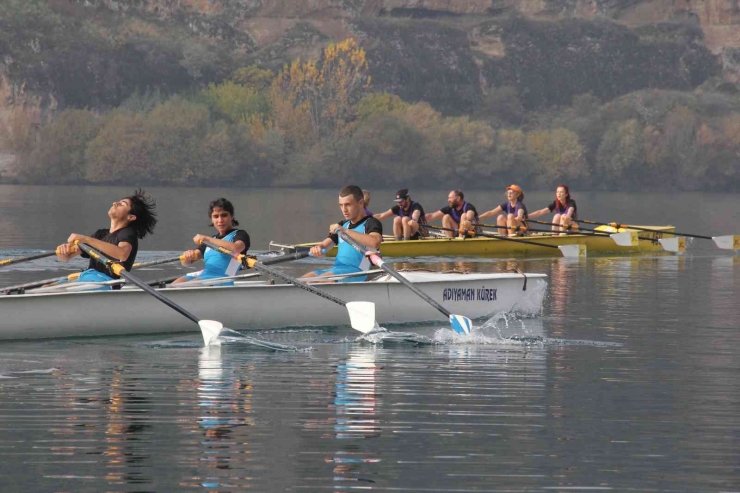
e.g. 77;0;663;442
481;17;720;109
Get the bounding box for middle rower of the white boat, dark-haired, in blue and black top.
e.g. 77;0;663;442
172;197;250;286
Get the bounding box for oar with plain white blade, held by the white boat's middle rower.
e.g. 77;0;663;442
201;240;376;334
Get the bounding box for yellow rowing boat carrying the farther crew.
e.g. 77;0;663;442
270;226;676;257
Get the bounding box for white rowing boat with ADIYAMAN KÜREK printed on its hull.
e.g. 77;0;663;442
0;272;547;339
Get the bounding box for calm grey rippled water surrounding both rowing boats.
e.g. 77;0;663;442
0;186;740;492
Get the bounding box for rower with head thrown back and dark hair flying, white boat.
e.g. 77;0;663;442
57;190;157;290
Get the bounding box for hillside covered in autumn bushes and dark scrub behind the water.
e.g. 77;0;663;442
0;0;740;190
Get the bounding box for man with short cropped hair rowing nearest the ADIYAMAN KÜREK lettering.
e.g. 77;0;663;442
303;185;383;282
